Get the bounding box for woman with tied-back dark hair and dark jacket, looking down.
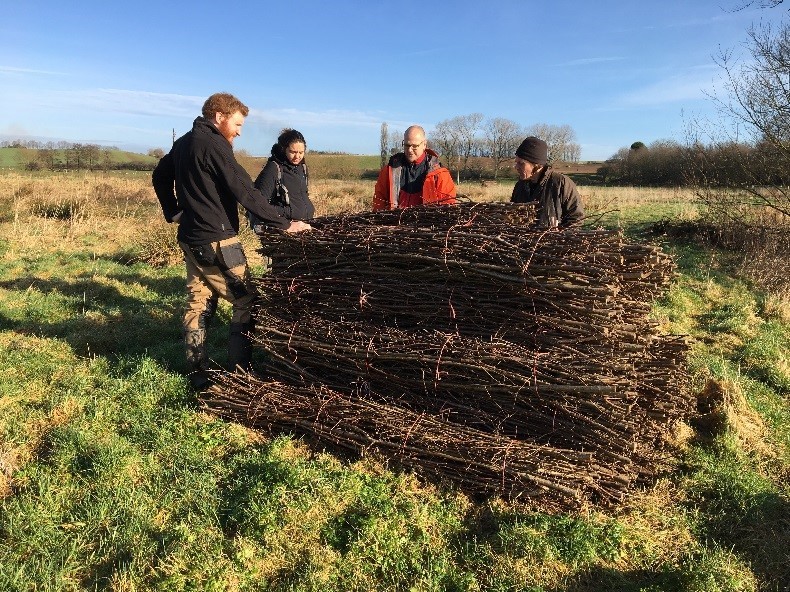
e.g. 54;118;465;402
249;129;315;230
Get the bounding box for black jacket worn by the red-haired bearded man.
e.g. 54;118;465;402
151;117;290;245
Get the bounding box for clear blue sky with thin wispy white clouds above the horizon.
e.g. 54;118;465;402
0;0;788;160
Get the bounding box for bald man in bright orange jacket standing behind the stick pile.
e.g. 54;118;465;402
373;125;455;211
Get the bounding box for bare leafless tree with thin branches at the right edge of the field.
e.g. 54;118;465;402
687;17;790;291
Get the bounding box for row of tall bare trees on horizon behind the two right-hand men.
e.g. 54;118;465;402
380;113;581;179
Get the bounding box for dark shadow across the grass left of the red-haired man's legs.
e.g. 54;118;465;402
0;256;217;370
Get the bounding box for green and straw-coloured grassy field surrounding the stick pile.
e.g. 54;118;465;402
0;169;790;592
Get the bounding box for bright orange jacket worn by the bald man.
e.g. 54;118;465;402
373;149;455;211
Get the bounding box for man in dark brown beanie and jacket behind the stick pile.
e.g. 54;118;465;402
510;136;584;228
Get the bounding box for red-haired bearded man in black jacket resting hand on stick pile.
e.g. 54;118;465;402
152;93;310;389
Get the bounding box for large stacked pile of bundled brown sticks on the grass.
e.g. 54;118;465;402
204;204;690;509
